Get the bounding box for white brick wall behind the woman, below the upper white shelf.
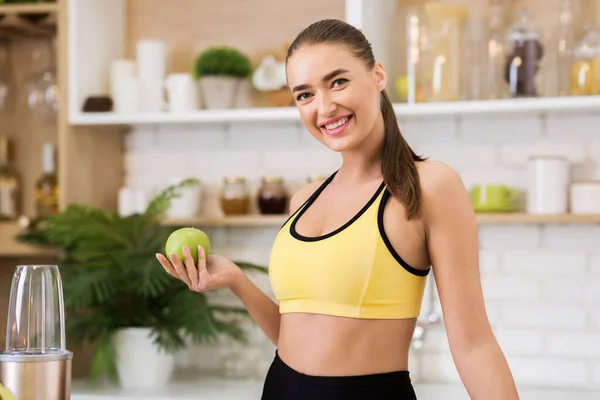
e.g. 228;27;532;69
125;113;600;389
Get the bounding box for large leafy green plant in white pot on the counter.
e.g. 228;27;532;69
17;179;266;388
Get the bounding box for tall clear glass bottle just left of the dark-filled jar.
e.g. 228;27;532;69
484;0;505;99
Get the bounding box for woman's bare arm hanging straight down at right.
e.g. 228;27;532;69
420;162;519;400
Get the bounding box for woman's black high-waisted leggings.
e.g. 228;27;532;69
261;352;417;400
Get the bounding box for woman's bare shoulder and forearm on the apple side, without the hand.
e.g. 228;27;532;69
230;182;321;345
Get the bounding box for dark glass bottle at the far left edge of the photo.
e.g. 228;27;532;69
0;136;21;221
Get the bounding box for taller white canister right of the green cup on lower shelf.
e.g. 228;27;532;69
527;156;570;214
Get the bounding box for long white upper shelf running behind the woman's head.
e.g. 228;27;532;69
70;96;600;126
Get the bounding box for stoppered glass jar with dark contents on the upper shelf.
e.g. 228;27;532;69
504;8;544;97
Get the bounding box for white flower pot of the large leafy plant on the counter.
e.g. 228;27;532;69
113;328;175;389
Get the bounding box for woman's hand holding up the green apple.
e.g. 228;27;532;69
156;246;242;292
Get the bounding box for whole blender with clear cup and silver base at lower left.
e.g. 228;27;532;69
0;265;73;400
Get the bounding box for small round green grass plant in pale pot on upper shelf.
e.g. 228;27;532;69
193;46;252;109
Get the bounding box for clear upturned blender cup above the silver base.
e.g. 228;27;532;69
5;265;66;355
